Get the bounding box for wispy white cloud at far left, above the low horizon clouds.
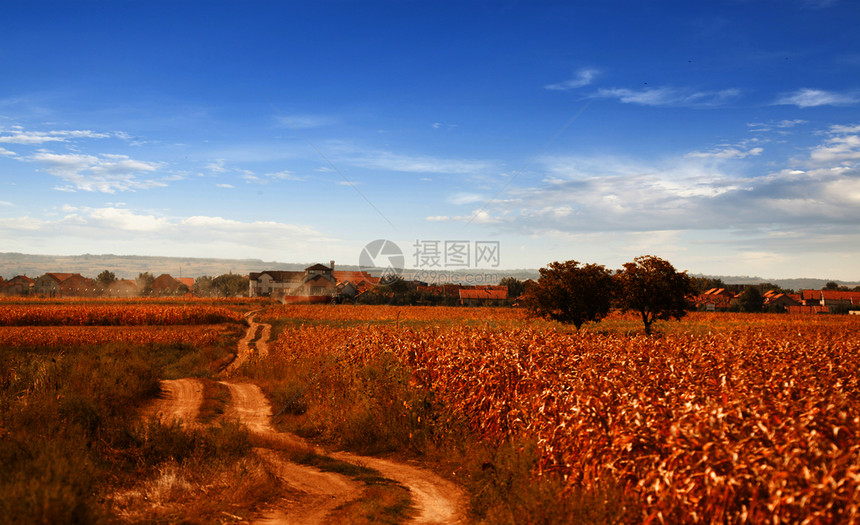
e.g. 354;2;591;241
26;151;166;193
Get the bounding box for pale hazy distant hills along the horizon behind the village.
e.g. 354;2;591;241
0;252;860;290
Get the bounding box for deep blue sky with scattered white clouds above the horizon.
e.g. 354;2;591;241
0;0;860;281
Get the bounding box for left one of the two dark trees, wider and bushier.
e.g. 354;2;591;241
523;260;614;330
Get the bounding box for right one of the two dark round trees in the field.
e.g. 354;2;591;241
615;255;695;335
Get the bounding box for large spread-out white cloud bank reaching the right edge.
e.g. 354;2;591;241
460;126;860;235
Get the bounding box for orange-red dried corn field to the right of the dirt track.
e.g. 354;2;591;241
273;307;860;523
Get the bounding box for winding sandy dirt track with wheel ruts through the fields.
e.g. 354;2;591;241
152;312;465;525
